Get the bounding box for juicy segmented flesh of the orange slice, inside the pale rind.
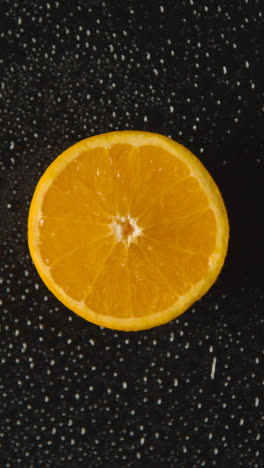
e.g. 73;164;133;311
38;144;217;318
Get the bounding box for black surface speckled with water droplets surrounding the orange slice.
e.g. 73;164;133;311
0;0;264;468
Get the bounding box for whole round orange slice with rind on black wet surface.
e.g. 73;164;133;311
28;131;229;331
